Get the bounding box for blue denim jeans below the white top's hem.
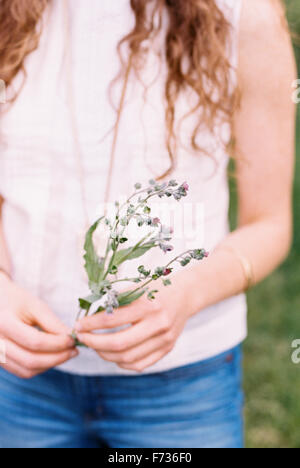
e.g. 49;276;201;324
0;347;243;448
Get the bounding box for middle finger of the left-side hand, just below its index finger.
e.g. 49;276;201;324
6;341;78;371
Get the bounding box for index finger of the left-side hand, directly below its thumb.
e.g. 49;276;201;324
2;320;74;353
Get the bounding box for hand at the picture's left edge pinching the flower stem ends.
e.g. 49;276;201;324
0;273;78;379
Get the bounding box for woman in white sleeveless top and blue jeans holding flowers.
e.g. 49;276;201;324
0;0;295;448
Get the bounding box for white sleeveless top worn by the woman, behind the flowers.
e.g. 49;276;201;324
0;0;247;375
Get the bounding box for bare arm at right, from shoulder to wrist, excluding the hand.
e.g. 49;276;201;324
180;0;296;316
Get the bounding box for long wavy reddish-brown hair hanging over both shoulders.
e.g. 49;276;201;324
0;0;237;176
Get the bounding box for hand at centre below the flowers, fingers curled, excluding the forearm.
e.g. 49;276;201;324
76;275;190;372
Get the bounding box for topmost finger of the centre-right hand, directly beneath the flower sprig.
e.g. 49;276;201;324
75;307;145;333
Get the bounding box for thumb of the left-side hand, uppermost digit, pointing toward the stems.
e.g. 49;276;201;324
30;299;72;335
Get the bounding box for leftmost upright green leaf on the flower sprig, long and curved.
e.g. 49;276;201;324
84;216;104;284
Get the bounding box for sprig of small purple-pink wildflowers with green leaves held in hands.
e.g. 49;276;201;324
77;179;209;324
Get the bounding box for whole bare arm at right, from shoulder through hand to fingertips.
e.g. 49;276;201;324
78;0;295;371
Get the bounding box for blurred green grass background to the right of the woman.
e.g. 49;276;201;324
232;0;300;448
